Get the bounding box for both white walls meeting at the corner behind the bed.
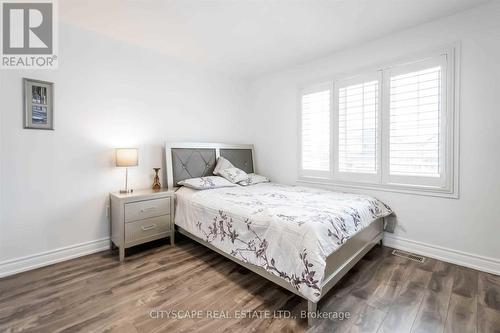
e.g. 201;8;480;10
0;2;500;276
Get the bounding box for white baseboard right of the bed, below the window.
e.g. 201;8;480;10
384;232;500;275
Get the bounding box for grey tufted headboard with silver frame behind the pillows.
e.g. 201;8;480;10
165;142;255;188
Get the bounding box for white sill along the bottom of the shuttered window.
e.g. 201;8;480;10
297;177;459;199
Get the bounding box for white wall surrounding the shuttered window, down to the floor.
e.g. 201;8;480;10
252;2;500;273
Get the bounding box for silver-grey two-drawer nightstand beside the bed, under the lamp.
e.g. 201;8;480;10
110;189;175;261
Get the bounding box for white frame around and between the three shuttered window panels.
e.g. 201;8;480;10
297;42;460;198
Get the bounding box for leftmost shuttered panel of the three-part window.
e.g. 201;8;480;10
300;84;332;175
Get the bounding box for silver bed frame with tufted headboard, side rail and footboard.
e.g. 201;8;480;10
165;142;384;324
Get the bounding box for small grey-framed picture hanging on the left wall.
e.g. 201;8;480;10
23;78;54;130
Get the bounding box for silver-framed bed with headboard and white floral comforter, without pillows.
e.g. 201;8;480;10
165;143;392;322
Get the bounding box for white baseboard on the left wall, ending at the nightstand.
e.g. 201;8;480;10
0;237;110;278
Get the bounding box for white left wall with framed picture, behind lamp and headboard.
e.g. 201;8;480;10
0;24;249;275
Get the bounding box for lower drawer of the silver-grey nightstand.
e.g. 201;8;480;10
125;215;170;243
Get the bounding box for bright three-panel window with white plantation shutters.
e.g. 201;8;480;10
300;48;458;196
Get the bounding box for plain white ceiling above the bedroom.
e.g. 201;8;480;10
59;0;486;76
